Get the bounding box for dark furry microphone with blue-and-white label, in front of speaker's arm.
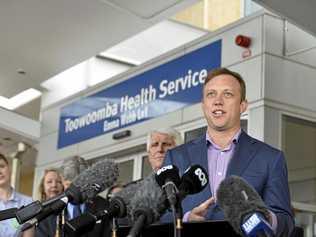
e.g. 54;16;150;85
217;176;274;237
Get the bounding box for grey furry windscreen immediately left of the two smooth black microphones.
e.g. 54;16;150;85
128;173;166;225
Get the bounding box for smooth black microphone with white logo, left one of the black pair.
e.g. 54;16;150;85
155;165;180;209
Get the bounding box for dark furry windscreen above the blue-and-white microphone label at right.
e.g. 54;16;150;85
216;176;269;235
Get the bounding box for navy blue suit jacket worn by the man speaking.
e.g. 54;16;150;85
162;132;294;236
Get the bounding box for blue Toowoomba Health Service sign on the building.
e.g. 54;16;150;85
58;40;222;149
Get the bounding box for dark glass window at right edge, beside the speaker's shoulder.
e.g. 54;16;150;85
282;116;316;204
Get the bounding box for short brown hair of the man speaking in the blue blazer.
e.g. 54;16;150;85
203;67;246;101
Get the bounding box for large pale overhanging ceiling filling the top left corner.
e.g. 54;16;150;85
0;0;196;98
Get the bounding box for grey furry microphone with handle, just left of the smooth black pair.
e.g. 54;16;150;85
128;174;167;237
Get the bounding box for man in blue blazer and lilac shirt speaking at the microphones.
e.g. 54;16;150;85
164;68;294;236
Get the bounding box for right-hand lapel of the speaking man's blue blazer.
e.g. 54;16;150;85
226;132;256;177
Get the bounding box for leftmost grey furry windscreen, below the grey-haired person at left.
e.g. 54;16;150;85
71;159;119;203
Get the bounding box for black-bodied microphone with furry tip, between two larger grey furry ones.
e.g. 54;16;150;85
65;181;140;236
